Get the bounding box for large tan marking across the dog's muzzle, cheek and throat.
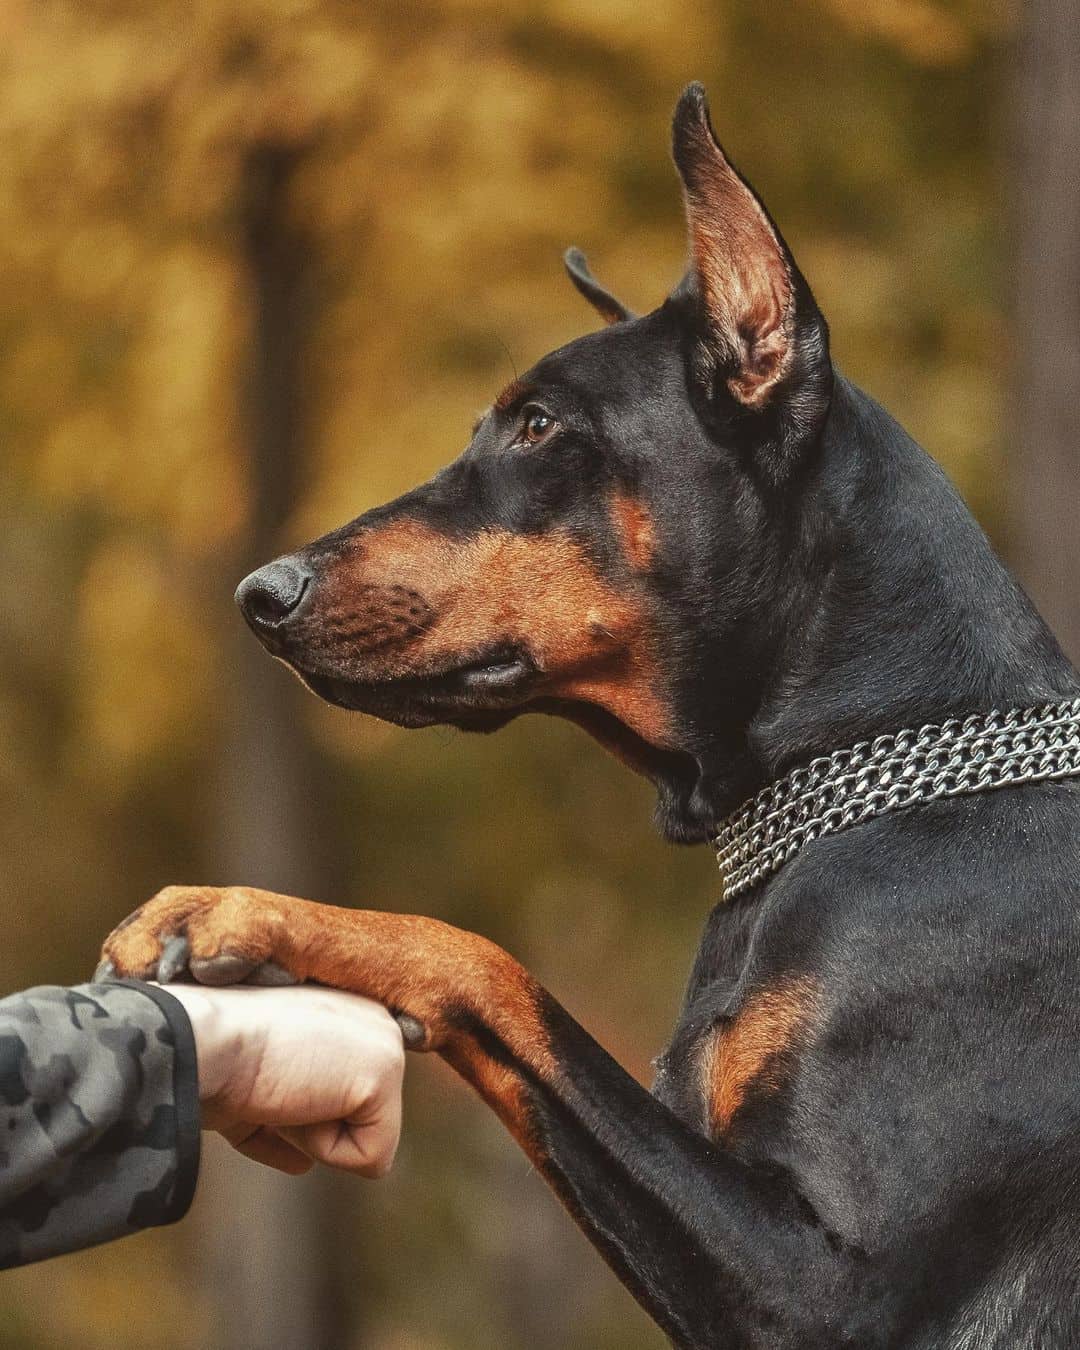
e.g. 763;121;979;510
307;521;671;747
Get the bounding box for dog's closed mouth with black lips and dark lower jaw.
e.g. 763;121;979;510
286;645;540;730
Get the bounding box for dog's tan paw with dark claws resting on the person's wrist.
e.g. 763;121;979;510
95;886;298;986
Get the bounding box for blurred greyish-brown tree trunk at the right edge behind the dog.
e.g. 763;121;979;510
1013;0;1080;662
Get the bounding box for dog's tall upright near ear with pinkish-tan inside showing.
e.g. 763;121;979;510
672;84;828;450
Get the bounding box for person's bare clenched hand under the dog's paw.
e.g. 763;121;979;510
167;984;405;1177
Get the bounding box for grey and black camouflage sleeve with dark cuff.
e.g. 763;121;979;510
0;983;198;1268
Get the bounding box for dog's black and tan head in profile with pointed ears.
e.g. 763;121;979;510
236;85;832;840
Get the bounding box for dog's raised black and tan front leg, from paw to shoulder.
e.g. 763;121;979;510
104;887;848;1347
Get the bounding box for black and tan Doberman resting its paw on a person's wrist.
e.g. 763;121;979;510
97;85;1080;1350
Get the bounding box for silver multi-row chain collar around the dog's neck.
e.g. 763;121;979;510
716;698;1080;900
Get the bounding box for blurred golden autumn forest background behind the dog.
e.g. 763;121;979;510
0;0;1080;1350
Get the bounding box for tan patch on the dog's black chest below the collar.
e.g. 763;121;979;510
702;977;818;1135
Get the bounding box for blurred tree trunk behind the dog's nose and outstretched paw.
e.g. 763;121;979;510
201;146;358;1350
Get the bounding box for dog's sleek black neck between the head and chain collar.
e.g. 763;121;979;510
666;377;1080;822
